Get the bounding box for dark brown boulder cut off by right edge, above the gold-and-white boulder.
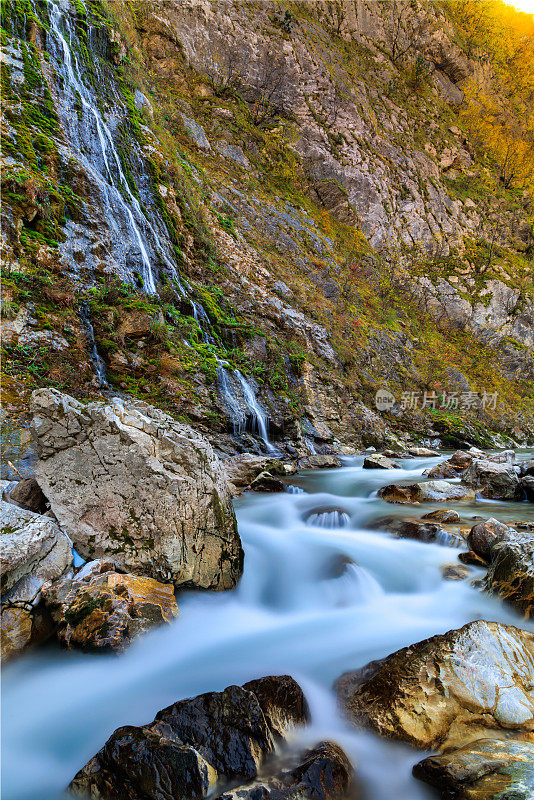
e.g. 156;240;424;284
486;528;534;618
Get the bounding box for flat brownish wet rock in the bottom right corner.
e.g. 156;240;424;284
413;739;534;800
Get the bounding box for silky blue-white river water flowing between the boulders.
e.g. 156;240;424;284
2;453;534;800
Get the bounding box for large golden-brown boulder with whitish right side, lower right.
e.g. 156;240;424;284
336;620;534;751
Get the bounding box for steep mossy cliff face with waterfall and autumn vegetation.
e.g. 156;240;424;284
2;0;534;451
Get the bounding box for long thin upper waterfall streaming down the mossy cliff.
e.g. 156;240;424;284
48;0;183;294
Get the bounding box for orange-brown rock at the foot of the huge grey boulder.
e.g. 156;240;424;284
43;561;178;652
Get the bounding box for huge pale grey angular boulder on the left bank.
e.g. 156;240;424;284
32;389;243;589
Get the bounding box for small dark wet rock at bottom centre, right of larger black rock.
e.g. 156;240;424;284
217;742;354;800
